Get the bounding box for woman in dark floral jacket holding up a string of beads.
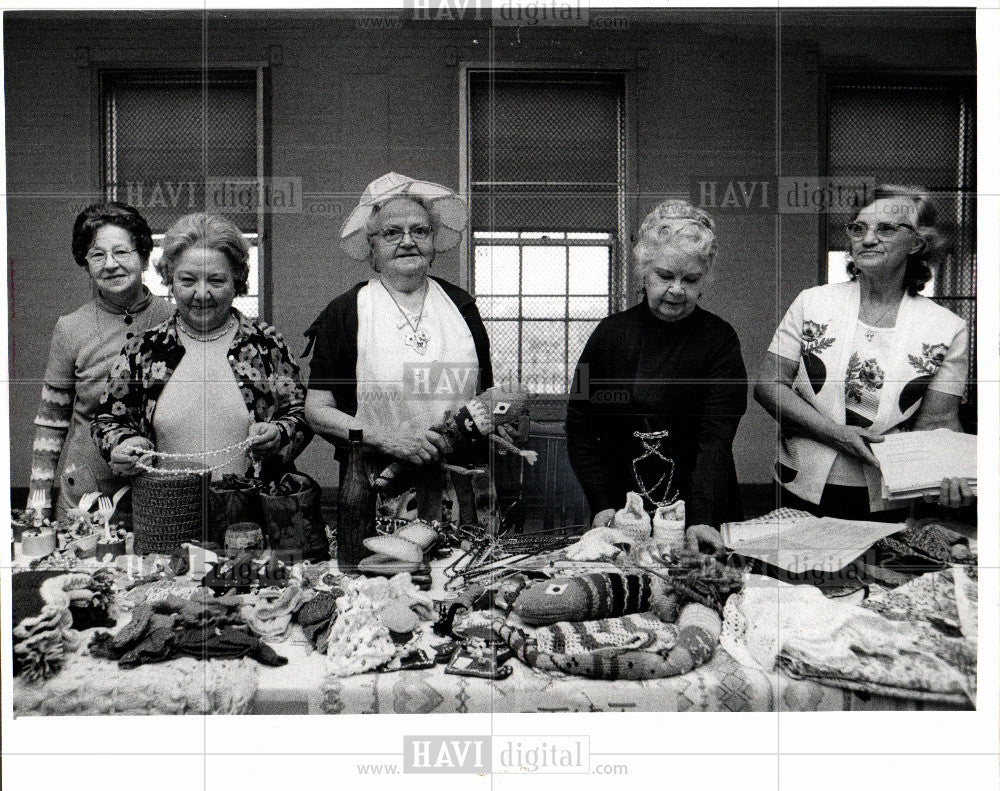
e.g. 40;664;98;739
91;214;312;478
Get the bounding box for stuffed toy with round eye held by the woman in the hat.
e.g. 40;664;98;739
373;386;538;497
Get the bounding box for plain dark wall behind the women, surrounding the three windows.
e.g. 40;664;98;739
4;8;975;486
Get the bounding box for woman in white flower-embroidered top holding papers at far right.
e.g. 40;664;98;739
754;185;973;521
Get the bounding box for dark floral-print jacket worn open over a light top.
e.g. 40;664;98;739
90;310;312;474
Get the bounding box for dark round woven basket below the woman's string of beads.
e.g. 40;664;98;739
132;473;208;555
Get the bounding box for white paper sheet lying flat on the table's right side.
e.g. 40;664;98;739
721;509;906;574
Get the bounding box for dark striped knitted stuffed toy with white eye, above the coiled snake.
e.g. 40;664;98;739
513;574;652;626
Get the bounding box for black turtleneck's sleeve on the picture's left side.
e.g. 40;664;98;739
566;325;618;514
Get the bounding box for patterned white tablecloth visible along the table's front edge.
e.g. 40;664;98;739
244;634;968;714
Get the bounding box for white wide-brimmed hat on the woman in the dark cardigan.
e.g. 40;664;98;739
340;173;469;261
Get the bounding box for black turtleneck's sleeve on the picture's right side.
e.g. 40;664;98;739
686;325;747;527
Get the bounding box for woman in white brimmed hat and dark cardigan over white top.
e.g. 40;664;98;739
306;173;493;519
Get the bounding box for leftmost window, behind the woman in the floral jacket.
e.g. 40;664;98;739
101;71;263;318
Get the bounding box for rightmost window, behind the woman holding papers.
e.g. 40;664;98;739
827;79;976;425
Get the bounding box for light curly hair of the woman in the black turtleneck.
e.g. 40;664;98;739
633;199;717;274
